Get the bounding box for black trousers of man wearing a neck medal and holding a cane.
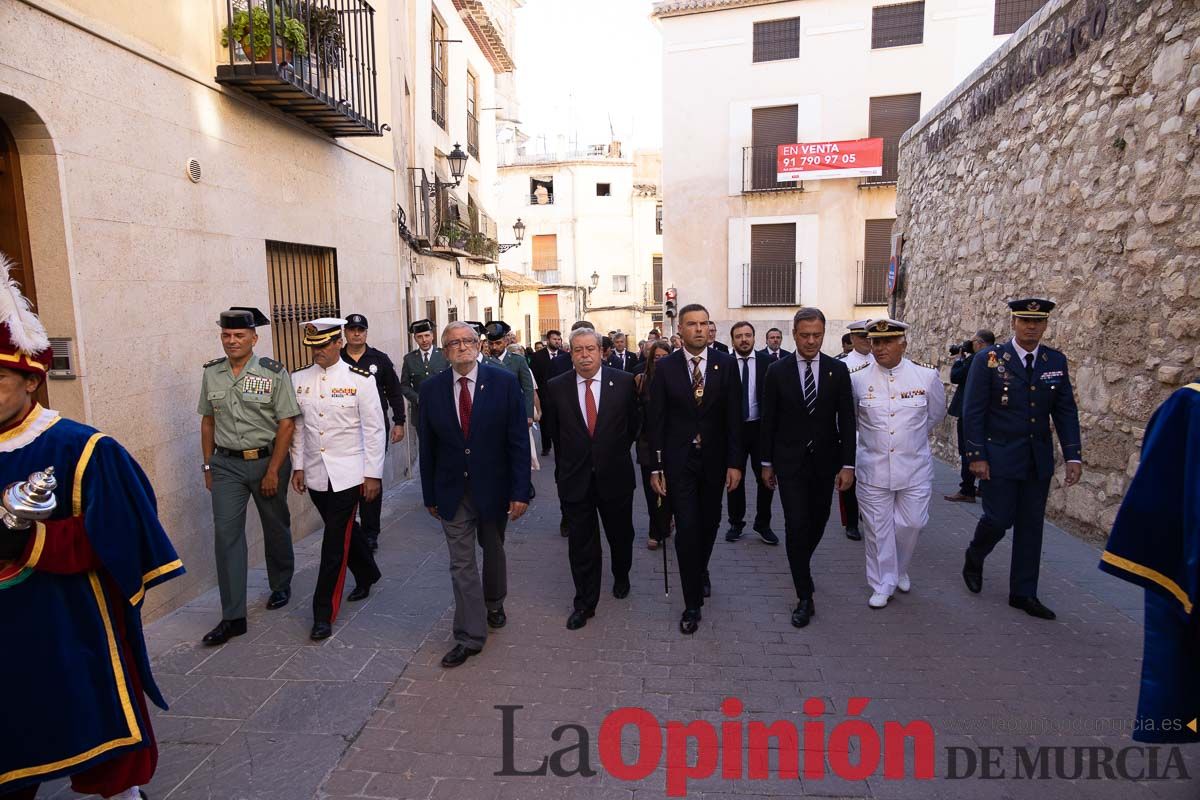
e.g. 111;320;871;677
666;447;725;608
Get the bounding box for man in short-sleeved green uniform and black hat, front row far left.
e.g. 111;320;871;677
198;306;300;645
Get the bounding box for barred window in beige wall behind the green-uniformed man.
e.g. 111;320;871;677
266;241;341;372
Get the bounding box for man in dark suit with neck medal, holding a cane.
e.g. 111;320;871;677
647;303;745;633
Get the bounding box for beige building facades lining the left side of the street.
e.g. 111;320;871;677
0;0;520;614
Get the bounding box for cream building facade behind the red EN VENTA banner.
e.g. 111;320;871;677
653;0;1036;351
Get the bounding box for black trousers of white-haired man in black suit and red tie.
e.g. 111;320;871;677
563;475;634;612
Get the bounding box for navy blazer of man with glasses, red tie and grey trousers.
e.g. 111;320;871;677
418;363;533;519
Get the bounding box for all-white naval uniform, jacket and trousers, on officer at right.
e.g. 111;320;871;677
850;359;946;596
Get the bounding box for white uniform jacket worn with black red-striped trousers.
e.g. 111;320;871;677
292;360;385;492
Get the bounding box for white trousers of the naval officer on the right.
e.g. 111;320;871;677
854;482;934;596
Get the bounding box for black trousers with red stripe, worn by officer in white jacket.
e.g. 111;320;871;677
308;486;380;622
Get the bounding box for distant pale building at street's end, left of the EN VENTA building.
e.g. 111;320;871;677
499;143;662;342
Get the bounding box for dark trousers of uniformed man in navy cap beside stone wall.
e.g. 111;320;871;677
967;477;1050;597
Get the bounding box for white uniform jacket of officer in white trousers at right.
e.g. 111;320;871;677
850;359;946;491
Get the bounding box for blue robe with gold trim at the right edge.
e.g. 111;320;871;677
1100;383;1200;742
